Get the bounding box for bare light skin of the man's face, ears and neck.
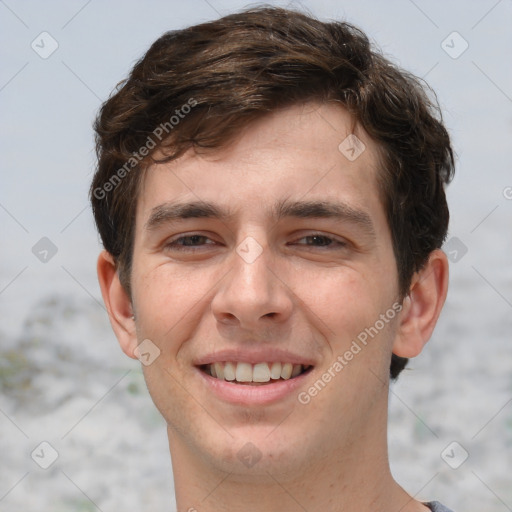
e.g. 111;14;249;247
98;104;448;512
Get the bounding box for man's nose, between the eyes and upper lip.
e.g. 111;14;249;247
211;237;293;330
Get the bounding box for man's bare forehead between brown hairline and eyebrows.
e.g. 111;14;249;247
137;103;382;225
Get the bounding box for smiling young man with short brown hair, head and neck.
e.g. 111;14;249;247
91;8;453;512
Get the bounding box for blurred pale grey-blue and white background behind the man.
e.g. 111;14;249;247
0;0;512;512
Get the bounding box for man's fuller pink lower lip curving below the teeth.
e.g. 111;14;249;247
197;368;312;405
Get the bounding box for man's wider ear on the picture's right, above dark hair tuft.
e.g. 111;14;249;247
393;249;448;358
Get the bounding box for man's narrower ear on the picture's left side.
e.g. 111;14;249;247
97;251;137;359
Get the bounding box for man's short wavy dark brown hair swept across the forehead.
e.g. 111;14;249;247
90;7;454;378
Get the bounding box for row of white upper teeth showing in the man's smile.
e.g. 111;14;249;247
207;361;304;382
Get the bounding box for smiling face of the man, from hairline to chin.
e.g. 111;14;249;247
131;104;400;475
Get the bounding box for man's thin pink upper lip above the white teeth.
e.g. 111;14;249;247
194;348;315;366
